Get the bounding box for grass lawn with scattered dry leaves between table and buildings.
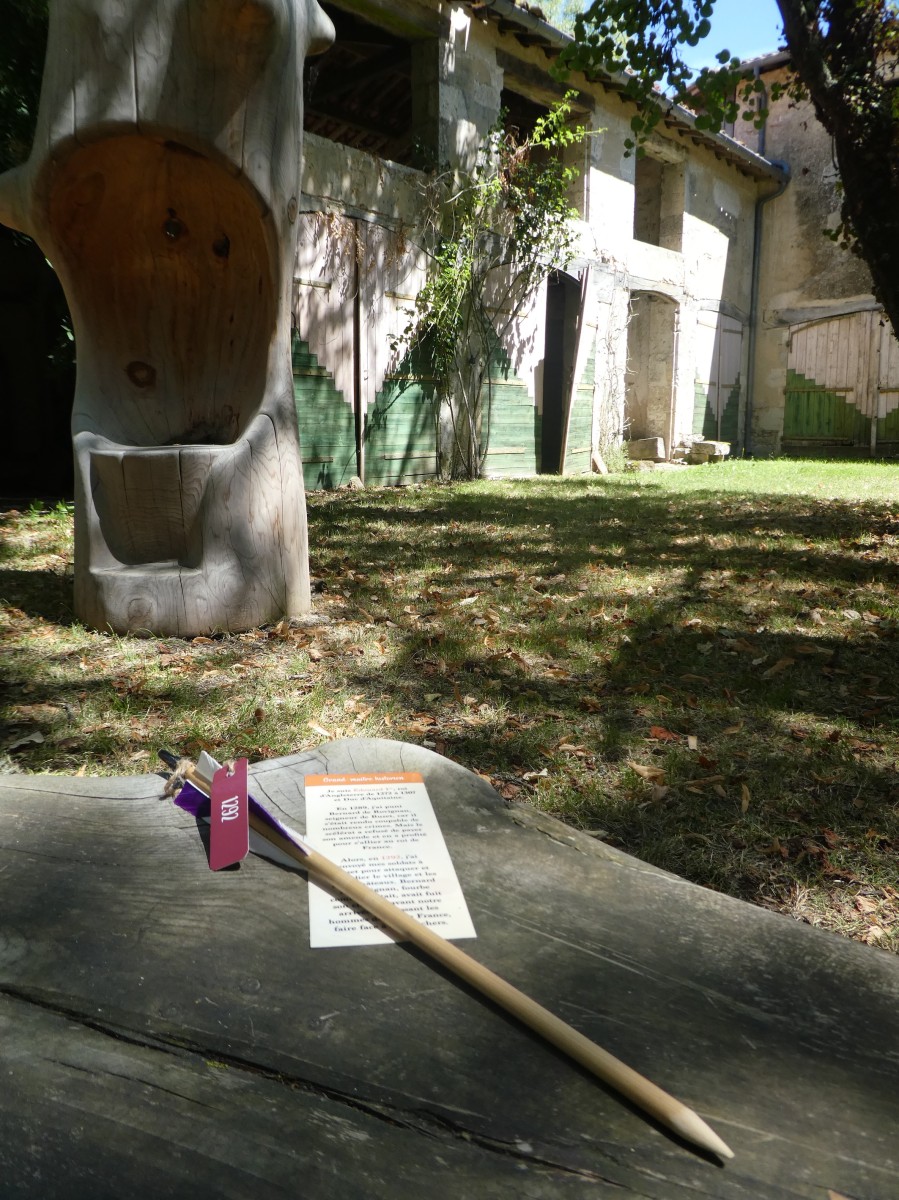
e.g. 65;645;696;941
0;461;899;952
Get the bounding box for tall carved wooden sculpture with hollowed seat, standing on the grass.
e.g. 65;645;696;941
0;0;334;635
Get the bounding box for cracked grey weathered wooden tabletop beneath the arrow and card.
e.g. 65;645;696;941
0;740;899;1200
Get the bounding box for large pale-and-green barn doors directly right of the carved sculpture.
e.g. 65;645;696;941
294;214;437;487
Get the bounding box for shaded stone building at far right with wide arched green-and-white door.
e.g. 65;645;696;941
735;52;899;457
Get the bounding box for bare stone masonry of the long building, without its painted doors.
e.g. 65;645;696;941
297;0;760;475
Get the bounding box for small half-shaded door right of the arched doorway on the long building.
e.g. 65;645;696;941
693;312;743;443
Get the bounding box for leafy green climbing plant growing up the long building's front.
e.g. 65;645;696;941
398;95;588;479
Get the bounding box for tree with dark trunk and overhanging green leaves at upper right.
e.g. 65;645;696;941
559;0;899;338
